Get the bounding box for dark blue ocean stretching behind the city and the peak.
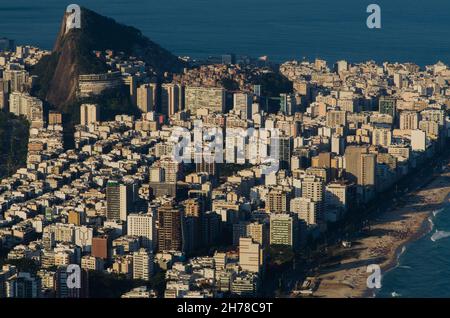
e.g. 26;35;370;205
0;0;450;66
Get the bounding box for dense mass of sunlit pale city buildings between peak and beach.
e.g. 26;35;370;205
0;40;450;298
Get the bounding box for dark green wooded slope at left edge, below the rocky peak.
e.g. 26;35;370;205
0;111;29;178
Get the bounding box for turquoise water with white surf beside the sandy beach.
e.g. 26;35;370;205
377;204;450;298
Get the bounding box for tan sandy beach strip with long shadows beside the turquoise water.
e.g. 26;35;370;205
314;166;450;298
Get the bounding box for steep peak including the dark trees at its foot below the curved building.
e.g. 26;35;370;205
30;8;185;148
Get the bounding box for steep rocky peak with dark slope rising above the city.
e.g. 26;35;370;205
33;8;185;108
